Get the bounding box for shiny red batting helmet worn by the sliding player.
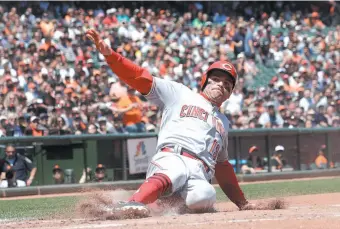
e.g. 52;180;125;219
201;61;238;91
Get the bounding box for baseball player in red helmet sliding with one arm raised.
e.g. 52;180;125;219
86;29;253;217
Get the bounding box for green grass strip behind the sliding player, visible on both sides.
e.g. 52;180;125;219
0;178;340;219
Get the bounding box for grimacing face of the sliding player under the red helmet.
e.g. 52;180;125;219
204;70;233;104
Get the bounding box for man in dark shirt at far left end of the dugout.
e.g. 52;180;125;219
1;144;37;186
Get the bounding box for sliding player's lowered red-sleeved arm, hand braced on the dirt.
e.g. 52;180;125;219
215;160;250;210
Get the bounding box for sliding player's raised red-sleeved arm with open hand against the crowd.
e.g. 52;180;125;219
86;29;153;95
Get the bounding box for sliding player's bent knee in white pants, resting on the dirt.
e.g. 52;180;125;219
181;179;216;212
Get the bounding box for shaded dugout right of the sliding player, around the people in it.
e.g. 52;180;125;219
229;128;340;172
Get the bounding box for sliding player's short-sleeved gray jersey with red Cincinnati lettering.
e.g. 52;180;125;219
145;77;229;171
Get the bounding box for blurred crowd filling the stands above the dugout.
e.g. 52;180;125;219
0;1;340;136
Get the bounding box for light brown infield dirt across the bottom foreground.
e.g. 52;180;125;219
0;193;340;229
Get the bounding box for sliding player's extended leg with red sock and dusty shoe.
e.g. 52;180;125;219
108;152;187;218
